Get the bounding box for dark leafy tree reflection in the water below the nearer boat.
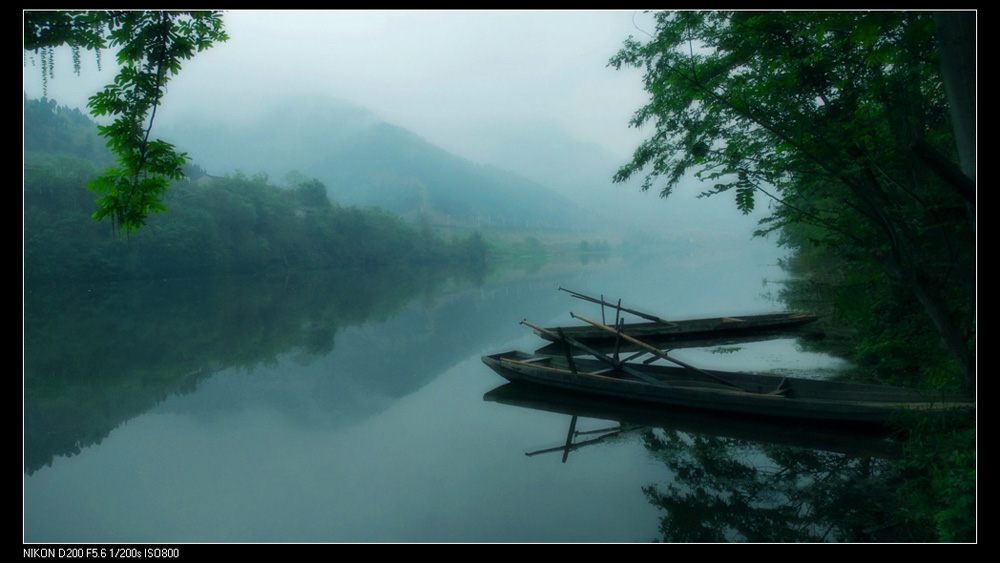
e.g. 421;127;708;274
642;429;889;542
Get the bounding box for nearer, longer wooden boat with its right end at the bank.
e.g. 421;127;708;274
482;351;975;424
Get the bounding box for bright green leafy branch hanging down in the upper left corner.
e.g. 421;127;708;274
24;11;227;231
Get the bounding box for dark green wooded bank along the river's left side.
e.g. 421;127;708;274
24;99;487;282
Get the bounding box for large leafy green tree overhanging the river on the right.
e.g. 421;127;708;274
610;12;975;394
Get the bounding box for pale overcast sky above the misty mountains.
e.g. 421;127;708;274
24;10;650;162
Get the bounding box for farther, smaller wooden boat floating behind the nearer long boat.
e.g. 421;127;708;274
535;287;818;345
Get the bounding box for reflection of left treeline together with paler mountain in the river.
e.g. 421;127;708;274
24;260;600;473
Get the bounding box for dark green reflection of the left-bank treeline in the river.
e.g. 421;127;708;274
24;268;482;474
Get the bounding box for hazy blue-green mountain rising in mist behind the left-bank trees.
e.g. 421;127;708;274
159;97;580;229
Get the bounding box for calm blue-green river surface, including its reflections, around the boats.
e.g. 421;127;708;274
23;236;900;543
